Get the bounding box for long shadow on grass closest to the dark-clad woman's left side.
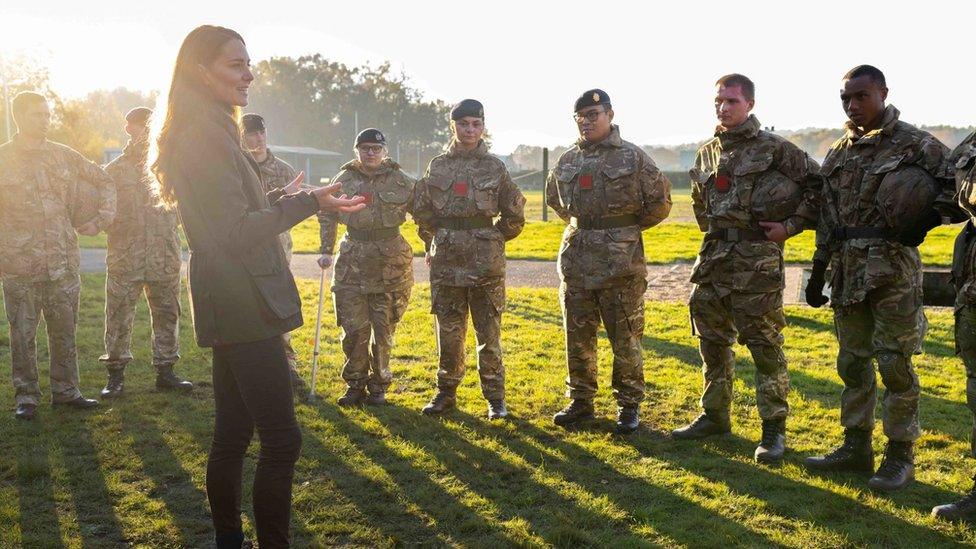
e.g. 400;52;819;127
120;402;212;547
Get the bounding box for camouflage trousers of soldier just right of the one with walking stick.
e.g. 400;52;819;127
430;281;505;400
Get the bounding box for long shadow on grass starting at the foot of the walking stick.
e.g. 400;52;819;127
296;402;512;545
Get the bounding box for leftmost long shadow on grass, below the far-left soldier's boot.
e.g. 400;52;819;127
14;418;61;547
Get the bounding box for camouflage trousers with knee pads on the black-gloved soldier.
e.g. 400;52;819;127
834;282;924;441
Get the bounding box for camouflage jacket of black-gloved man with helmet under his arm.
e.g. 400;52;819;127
814;105;954;307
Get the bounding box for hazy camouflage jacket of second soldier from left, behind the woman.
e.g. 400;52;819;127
105;141;180;282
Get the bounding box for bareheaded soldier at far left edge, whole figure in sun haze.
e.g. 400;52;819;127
0;92;115;419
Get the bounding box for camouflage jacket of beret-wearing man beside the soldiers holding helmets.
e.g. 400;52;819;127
546;126;671;289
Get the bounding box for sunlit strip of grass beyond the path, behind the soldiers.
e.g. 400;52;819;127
79;191;959;267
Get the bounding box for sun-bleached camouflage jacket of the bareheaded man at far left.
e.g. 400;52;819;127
0;132;115;282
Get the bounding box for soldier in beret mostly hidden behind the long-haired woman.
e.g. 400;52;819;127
241;113;305;389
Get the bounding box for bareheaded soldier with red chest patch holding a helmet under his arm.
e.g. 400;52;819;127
673;74;821;463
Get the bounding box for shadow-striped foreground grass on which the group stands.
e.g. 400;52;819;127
0;275;976;547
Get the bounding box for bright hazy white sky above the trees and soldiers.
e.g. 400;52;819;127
0;0;976;153
